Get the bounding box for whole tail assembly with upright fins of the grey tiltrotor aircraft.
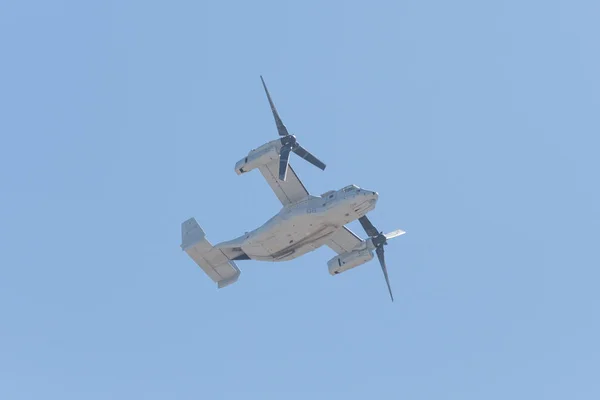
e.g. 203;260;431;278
181;218;241;289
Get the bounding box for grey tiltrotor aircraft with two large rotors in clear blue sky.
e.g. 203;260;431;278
181;76;405;301
